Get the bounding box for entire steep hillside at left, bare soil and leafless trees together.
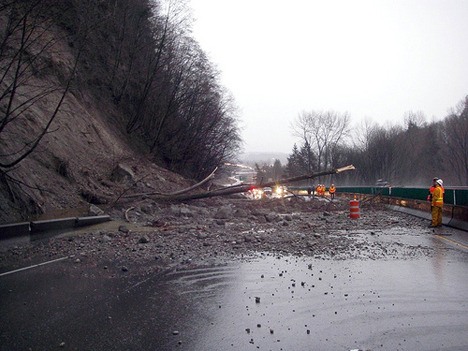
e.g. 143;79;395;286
0;0;240;223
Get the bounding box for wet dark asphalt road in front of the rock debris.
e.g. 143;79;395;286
0;230;468;351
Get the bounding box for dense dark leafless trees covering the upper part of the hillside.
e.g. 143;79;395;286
0;0;240;186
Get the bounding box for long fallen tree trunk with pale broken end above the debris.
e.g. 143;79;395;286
157;165;355;201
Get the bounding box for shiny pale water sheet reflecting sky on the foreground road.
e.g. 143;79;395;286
161;254;468;351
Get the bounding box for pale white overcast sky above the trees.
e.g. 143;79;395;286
189;0;468;153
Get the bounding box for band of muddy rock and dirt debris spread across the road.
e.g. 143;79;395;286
0;197;433;276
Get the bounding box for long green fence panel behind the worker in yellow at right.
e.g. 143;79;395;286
336;186;468;206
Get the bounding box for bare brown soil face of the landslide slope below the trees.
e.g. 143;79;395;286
0;79;193;223
